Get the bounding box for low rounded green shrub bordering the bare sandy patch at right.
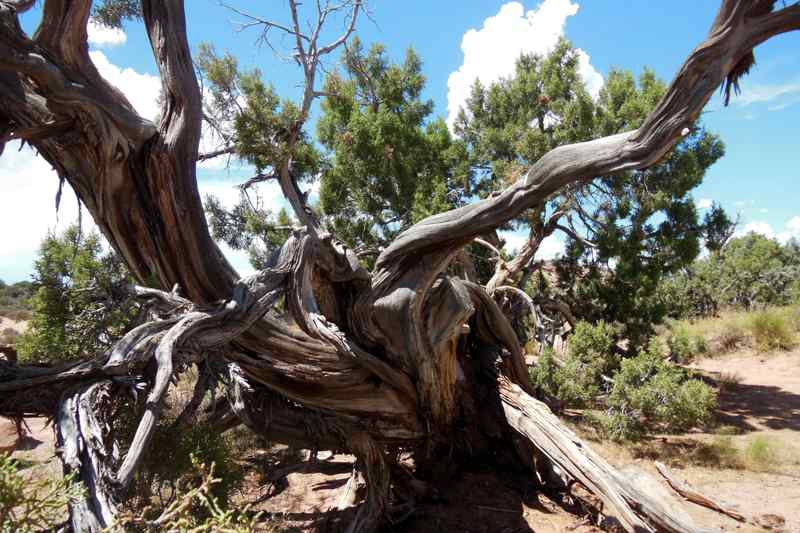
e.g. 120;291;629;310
595;338;716;440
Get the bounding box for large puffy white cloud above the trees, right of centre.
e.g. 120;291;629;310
447;0;603;126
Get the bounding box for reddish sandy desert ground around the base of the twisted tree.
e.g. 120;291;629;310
0;350;800;533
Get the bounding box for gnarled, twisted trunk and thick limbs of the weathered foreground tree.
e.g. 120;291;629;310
0;0;800;531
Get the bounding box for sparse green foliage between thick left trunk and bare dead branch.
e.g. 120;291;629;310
196;44;323;268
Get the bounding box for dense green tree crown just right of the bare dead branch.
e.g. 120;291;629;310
317;39;461;255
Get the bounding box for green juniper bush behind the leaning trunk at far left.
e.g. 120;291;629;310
17;222;137;361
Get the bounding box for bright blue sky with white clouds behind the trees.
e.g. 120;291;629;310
0;0;800;281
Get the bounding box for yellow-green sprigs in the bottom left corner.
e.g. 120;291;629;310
0;454;83;533
